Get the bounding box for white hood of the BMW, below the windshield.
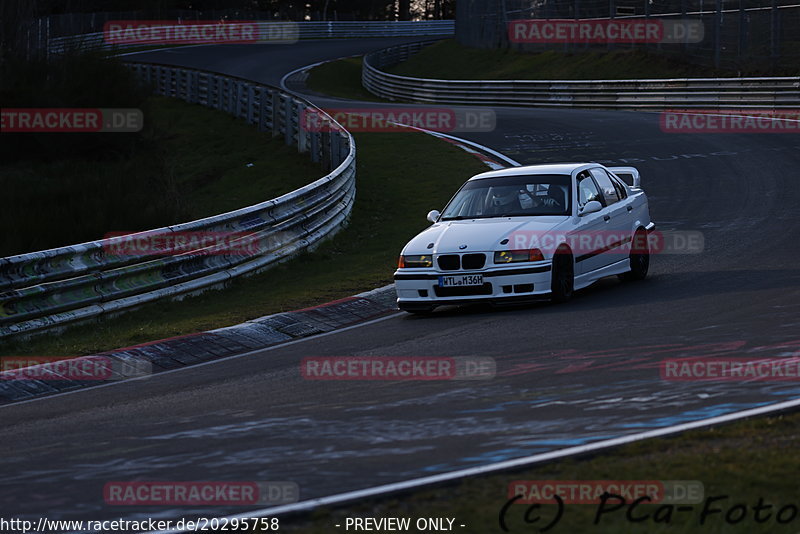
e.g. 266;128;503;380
403;215;570;254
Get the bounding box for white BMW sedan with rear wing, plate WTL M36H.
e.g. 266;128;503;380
394;163;655;313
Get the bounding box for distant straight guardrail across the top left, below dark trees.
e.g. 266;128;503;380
48;20;455;54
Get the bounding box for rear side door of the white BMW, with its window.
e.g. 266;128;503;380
589;167;632;267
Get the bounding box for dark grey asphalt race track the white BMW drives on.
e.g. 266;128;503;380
0;39;800;532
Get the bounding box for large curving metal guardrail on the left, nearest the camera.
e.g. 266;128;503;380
0;63;356;338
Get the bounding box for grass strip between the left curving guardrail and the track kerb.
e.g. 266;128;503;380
0;133;486;356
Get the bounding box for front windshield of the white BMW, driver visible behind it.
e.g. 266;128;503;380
441;174;571;221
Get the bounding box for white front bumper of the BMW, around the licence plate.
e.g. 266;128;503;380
394;261;552;311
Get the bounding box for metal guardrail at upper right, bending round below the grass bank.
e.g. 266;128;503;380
362;41;800;109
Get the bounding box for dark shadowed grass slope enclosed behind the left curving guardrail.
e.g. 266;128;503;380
0;97;324;256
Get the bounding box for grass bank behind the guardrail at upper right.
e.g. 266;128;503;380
386;39;797;80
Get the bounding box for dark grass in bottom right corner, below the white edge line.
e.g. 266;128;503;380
288;412;800;534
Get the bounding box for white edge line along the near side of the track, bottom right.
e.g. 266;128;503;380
153;398;800;534
